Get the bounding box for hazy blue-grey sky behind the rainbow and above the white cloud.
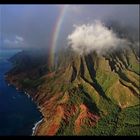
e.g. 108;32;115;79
0;5;139;48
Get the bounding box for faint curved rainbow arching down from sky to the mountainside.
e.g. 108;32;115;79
48;5;67;67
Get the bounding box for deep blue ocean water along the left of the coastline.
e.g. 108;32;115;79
0;50;42;136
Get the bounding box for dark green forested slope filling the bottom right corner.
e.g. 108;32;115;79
81;105;140;136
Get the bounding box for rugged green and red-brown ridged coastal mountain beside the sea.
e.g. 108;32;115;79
7;46;140;135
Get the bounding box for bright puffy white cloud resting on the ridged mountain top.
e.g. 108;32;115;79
67;21;128;55
